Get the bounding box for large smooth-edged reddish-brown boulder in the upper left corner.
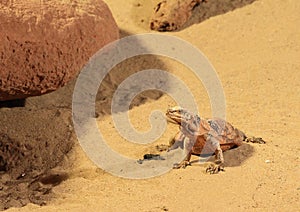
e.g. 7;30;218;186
0;0;119;101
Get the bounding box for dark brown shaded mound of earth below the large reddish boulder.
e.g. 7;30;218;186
0;108;74;209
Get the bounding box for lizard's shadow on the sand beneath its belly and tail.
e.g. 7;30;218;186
191;143;254;167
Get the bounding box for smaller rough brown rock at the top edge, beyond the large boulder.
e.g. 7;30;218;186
150;0;255;31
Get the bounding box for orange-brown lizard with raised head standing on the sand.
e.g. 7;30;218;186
166;106;264;174
